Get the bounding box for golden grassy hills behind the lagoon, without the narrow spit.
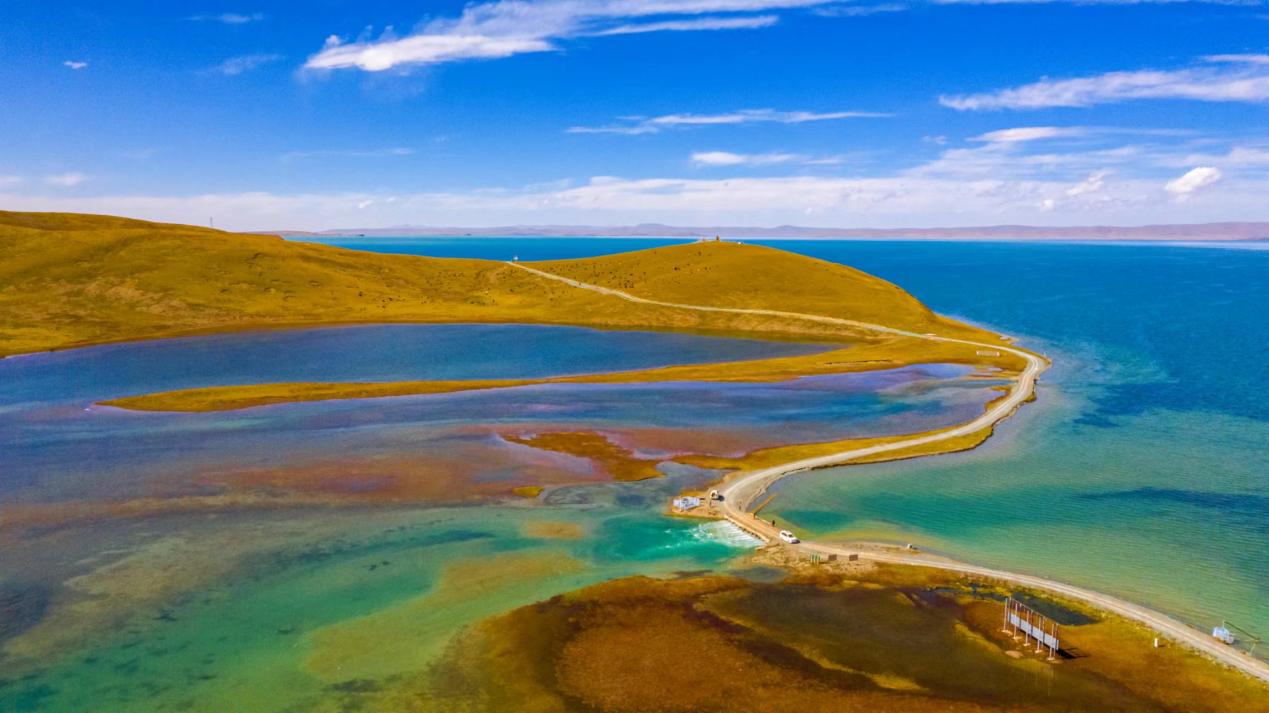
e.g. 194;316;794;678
0;212;1010;357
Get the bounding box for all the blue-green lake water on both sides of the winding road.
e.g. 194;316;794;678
0;239;1269;710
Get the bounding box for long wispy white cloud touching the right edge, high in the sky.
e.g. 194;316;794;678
939;55;1269;112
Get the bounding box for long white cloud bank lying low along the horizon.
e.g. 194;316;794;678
9;166;1264;230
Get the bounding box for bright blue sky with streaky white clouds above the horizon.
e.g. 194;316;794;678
0;0;1269;230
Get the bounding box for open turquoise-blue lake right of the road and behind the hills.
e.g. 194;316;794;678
307;239;1269;636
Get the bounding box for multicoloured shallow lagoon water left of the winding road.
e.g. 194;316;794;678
0;325;994;710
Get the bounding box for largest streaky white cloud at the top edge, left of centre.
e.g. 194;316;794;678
305;0;838;72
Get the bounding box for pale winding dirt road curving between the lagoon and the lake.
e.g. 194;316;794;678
508;257;1269;683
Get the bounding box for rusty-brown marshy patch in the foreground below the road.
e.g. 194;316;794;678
317;568;1269;713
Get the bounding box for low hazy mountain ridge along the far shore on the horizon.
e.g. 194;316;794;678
267;222;1269;241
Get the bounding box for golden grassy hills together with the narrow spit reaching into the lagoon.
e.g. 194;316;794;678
0;213;1022;411
